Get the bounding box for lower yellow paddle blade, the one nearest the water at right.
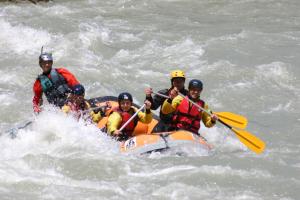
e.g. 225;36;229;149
231;128;265;154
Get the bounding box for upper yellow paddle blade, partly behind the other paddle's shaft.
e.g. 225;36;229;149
214;112;248;129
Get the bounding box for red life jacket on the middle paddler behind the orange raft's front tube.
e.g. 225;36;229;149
114;108;138;137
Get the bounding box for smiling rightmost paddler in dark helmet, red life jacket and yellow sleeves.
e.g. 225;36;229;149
162;79;218;135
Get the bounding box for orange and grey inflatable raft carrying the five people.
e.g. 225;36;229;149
89;96;212;154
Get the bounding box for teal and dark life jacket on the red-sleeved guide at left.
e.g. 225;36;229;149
38;69;71;107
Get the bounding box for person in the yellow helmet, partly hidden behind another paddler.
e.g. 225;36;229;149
145;70;188;132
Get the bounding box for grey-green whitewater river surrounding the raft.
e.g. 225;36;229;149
0;0;300;200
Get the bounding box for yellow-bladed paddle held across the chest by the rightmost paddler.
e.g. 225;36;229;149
179;92;265;154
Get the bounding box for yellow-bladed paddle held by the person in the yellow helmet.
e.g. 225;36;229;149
153;92;248;129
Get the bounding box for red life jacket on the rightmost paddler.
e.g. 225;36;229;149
172;96;205;134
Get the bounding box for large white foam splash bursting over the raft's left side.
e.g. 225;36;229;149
0;107;119;160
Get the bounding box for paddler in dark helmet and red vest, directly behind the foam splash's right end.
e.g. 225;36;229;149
106;92;152;141
